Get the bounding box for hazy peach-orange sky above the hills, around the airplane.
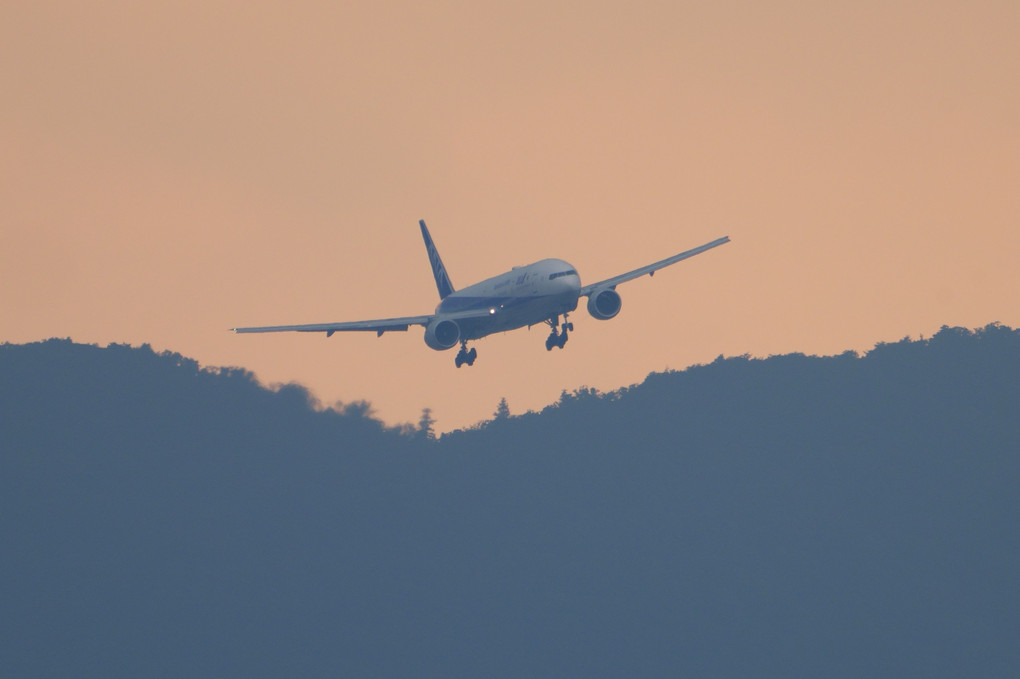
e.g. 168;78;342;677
0;0;1020;430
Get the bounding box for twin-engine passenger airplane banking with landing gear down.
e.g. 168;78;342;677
232;219;729;368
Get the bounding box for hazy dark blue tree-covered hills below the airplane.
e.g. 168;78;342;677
0;326;1020;677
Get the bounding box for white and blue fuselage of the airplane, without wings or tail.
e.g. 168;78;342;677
436;259;580;340
